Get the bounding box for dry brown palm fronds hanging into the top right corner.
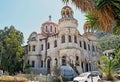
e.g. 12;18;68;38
62;0;120;32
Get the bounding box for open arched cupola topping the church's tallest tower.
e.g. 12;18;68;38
61;6;73;18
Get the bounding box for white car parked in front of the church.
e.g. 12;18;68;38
73;72;101;82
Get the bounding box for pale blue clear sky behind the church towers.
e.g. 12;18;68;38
0;0;86;44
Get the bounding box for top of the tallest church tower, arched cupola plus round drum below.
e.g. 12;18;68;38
59;6;78;31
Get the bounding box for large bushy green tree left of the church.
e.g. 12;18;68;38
0;26;24;74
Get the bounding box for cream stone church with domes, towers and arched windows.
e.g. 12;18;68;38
24;6;100;74
